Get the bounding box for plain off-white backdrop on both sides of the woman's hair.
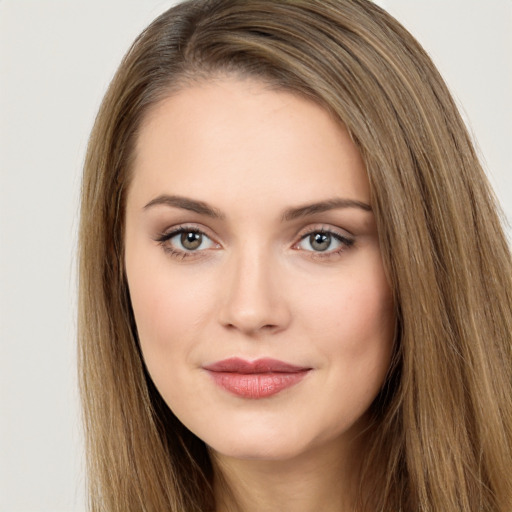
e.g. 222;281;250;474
0;0;512;512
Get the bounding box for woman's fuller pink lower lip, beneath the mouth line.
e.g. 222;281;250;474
208;370;309;399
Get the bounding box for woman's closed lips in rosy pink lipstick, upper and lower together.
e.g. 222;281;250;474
203;357;311;399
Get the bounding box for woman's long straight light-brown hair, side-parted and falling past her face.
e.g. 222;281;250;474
78;0;512;512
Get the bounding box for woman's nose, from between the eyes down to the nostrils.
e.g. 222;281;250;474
219;247;291;336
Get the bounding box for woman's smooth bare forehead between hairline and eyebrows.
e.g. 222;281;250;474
130;79;369;209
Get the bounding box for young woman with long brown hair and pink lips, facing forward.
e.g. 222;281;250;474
79;0;512;512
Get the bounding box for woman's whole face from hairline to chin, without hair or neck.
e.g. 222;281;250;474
126;79;394;460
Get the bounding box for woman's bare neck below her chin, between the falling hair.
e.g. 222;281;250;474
212;434;361;512
